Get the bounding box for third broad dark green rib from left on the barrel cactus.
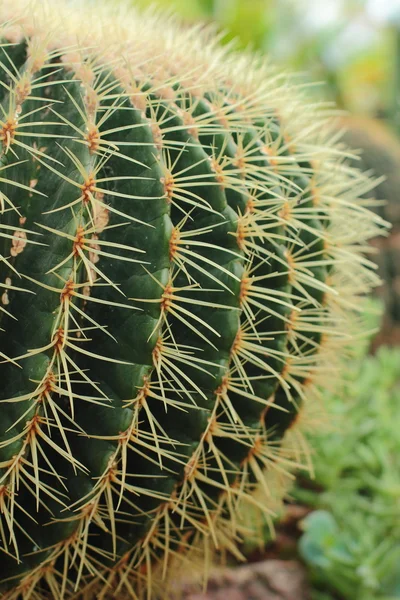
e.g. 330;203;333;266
145;94;243;392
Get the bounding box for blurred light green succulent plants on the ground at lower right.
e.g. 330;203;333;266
293;336;400;600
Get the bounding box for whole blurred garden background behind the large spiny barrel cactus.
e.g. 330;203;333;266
132;0;400;600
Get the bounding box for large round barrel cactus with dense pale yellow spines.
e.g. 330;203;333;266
0;0;382;600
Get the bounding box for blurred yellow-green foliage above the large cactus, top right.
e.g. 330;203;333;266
132;0;400;119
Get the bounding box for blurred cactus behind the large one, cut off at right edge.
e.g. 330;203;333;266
339;116;400;336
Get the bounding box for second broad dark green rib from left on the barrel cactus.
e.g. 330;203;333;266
61;82;179;553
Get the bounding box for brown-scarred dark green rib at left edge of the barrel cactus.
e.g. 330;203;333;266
0;64;98;579
